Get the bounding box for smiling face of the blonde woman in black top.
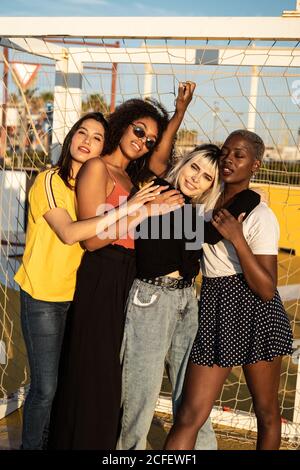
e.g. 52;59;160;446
178;155;215;197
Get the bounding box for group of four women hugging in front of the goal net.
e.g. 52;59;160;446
15;82;292;450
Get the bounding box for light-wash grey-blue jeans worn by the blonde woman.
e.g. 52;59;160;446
117;279;217;450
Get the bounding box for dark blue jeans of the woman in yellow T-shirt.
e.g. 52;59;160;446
20;289;71;449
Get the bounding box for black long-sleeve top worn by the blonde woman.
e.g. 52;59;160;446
135;178;260;281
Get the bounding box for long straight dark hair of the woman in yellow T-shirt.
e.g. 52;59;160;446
56;112;108;189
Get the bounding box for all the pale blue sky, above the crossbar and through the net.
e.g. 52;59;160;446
0;0;299;143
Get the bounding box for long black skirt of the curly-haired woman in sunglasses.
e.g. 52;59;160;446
49;245;136;450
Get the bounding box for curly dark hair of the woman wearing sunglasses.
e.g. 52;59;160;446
103;98;169;183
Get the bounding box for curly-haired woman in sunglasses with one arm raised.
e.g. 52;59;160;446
50;85;193;449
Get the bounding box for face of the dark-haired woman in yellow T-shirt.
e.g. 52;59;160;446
70;119;104;163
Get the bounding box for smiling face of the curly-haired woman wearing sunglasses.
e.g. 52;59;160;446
119;117;158;160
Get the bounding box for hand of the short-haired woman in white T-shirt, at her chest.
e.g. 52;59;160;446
211;209;245;245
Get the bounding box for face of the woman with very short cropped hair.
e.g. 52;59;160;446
219;135;260;184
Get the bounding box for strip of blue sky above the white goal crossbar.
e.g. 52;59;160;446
0;0;296;16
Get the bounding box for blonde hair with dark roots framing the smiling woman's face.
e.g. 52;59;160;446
165;144;221;211
